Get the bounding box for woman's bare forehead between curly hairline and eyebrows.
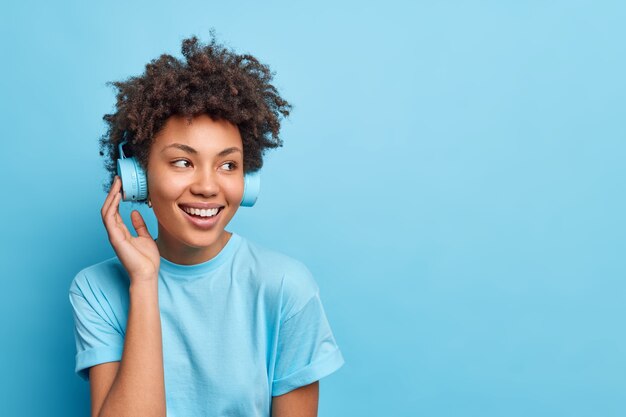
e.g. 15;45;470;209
151;115;243;153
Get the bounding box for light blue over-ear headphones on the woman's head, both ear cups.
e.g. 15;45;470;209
117;138;261;207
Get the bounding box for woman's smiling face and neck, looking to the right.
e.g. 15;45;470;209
147;115;244;265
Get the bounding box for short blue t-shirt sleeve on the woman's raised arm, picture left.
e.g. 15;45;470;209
69;276;124;381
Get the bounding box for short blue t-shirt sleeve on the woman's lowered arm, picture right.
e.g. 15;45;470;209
272;292;344;396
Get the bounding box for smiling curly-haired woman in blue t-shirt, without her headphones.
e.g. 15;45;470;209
69;37;344;417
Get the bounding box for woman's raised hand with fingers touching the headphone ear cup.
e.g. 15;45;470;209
100;176;161;283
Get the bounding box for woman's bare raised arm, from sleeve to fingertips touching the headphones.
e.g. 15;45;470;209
90;177;166;417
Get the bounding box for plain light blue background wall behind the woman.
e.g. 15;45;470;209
0;0;626;417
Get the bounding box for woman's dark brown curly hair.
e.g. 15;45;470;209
100;31;292;192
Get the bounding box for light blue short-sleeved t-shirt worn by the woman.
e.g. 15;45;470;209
69;233;344;417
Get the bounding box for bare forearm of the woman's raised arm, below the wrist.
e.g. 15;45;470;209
100;279;166;417
